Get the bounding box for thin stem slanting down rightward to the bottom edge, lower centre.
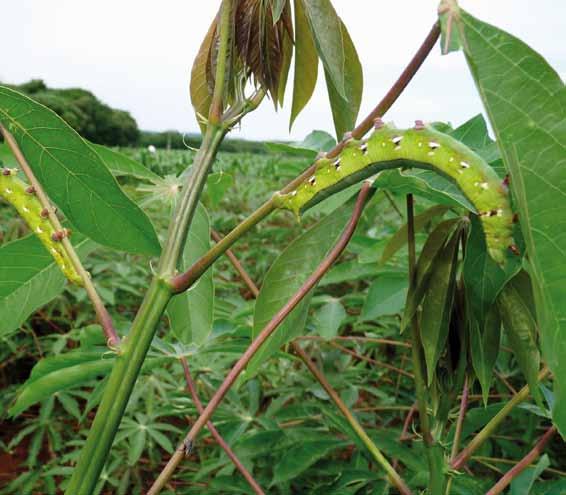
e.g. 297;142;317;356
292;342;412;495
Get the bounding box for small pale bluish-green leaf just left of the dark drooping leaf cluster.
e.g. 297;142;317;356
361;273;409;321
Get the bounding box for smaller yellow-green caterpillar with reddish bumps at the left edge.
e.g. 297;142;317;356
0;168;83;285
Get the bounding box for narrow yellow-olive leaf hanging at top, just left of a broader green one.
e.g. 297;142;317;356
289;0;318;128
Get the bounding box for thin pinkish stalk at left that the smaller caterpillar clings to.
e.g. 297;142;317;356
0;124;120;348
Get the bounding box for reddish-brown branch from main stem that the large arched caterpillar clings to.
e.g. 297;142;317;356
171;22;440;293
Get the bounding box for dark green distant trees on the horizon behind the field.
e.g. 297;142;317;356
5;79;266;153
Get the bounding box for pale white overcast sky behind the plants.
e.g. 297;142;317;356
0;0;566;139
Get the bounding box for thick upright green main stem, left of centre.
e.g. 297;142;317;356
65;0;237;495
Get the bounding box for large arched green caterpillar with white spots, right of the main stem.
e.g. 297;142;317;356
275;119;518;265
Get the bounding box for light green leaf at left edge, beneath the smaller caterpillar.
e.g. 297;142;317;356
0;236;95;336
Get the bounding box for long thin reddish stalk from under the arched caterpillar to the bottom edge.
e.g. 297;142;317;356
148;182;370;495
